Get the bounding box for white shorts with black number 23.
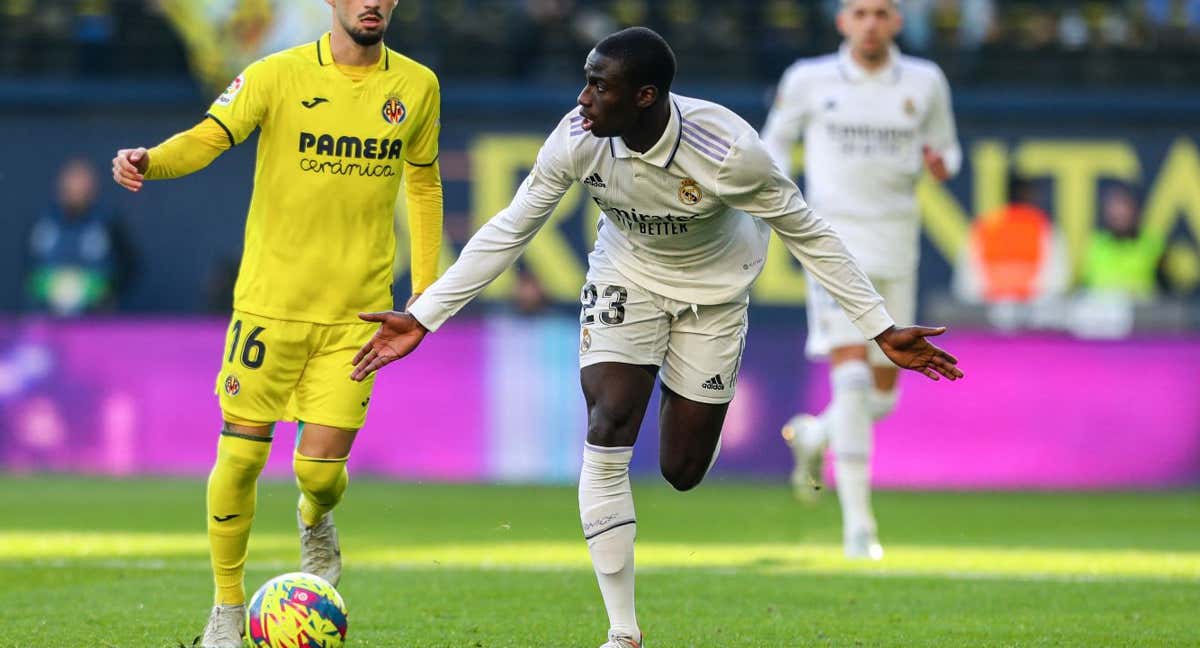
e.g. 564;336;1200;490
580;252;750;404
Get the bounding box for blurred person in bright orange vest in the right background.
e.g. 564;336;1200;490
954;176;1069;304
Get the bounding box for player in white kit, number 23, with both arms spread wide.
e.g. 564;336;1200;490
353;28;962;648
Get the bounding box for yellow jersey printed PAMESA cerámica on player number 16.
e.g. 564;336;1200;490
205;34;440;324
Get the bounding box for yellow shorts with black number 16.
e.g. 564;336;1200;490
216;311;378;430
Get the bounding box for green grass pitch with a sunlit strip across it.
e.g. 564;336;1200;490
0;476;1200;648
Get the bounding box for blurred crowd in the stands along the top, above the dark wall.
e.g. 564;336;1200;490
7;0;1200;84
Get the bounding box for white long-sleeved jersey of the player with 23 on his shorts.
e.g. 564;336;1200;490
410;94;893;337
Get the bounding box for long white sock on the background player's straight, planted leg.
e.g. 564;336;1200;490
829;361;875;535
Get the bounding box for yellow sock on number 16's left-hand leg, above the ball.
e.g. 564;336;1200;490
208;432;271;605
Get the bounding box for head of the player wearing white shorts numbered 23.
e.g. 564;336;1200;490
578;28;676;137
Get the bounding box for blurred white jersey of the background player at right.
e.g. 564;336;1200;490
762;46;962;277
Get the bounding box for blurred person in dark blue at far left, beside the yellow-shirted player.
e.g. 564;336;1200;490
26;157;134;317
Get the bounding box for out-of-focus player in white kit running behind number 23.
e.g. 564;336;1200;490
762;0;962;559
